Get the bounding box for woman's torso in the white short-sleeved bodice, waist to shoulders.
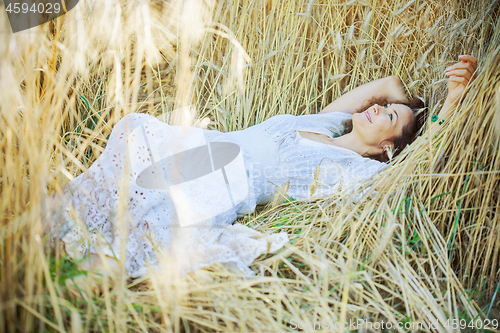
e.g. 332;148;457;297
209;112;385;204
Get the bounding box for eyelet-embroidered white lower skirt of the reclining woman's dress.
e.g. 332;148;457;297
53;114;288;277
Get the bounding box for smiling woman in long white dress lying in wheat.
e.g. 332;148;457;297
53;56;477;277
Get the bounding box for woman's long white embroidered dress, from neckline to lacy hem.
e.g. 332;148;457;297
53;112;386;277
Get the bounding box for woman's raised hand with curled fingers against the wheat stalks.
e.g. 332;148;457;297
445;55;477;103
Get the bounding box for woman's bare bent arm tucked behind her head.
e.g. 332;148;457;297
319;75;409;114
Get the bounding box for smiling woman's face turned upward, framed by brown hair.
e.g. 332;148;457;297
352;104;413;149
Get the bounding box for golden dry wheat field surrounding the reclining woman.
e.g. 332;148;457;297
0;0;500;332
